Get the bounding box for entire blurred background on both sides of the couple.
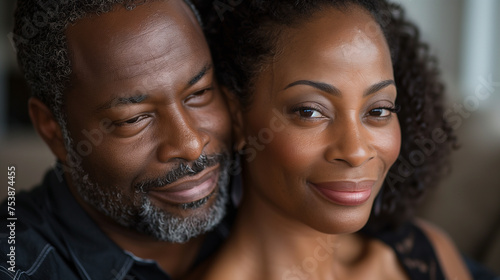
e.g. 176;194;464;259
0;0;500;274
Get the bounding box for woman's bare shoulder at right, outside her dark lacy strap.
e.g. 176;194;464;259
415;219;472;280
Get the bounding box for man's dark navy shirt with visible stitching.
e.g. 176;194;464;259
0;167;232;280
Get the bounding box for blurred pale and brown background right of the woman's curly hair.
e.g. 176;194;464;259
396;0;500;274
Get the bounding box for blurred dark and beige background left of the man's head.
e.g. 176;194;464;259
0;0;55;200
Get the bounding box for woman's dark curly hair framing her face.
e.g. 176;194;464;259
199;0;456;229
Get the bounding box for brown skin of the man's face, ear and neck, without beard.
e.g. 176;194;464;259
29;1;231;278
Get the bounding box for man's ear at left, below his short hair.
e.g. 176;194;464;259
28;97;67;162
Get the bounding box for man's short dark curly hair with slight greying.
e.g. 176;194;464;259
13;0;201;129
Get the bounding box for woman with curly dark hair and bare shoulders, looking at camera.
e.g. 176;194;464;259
190;0;470;280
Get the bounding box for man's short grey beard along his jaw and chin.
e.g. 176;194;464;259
63;129;230;243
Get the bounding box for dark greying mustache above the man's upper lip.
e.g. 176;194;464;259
135;153;227;193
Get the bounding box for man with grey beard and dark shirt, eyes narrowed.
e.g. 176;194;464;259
0;0;231;280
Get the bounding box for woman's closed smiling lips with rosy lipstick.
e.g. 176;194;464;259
310;180;375;206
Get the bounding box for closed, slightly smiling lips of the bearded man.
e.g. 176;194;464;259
149;165;219;204
